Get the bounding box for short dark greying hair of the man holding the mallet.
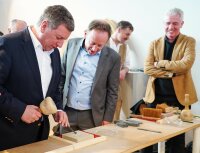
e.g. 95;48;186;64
38;5;74;31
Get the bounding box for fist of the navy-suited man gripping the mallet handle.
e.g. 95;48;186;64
21;105;42;124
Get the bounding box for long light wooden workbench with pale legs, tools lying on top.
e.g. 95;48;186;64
65;120;200;153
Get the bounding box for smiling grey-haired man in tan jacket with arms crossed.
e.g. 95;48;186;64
143;8;197;153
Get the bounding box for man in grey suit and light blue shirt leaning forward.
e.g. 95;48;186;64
60;20;120;132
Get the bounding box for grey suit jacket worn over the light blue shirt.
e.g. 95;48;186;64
60;38;120;126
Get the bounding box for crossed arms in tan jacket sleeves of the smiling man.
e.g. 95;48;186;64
145;38;195;77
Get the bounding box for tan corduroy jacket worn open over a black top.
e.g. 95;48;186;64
144;34;198;105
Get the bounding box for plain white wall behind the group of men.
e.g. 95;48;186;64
0;0;200;114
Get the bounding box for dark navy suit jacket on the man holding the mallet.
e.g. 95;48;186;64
0;29;62;150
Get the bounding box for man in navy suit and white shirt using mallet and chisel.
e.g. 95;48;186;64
0;5;74;150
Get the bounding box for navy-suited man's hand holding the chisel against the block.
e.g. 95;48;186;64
53;110;70;127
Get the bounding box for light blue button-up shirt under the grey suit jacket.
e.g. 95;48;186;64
67;47;101;110
